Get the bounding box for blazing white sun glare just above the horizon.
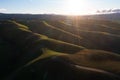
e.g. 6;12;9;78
64;0;88;15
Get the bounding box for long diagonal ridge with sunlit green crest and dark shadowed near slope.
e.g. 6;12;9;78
0;22;84;64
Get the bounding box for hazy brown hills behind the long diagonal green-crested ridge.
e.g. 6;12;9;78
18;19;120;53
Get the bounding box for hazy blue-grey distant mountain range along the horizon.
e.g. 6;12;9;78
0;13;120;21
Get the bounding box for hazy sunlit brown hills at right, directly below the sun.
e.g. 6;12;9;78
44;19;120;53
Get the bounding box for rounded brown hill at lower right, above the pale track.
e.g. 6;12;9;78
62;49;120;74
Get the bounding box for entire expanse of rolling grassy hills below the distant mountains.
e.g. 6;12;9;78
0;15;120;80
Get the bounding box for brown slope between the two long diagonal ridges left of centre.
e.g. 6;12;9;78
18;20;82;45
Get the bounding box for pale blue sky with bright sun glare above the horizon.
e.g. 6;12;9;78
0;0;120;15
